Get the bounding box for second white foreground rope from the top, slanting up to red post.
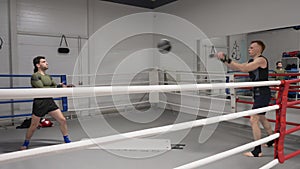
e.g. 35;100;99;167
0;105;279;164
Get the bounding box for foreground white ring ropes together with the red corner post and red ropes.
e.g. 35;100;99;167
0;76;300;169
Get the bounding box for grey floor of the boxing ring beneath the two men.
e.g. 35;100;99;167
0;110;300;169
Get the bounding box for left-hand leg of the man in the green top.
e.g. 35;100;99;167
20;114;41;150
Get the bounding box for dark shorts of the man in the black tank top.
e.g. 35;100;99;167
252;89;271;115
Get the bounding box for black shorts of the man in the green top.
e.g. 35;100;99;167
32;98;58;117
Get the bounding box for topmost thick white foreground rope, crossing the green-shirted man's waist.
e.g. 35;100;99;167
0;81;281;99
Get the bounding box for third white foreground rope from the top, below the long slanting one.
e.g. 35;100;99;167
174;133;280;169
